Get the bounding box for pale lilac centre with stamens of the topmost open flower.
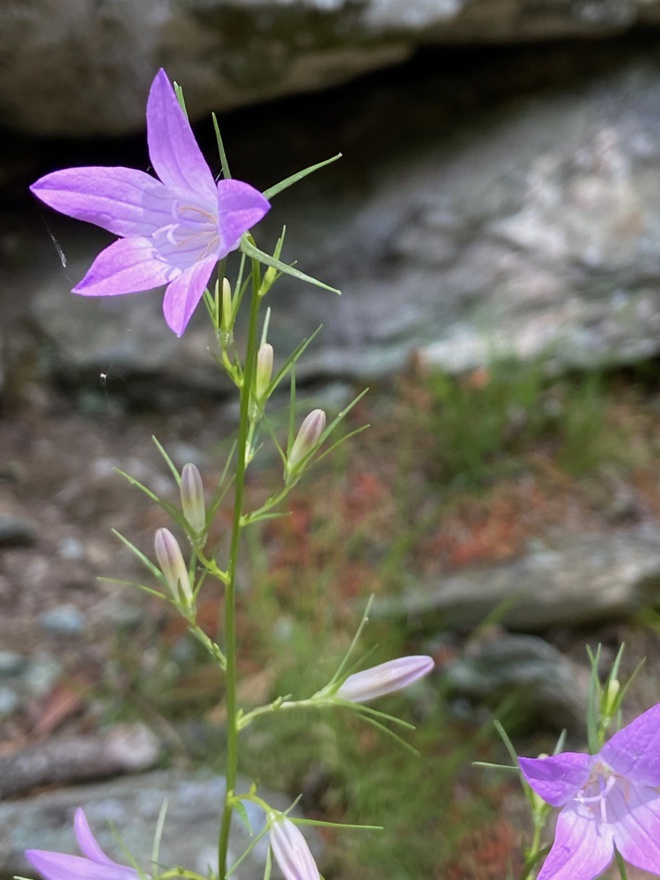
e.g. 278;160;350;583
154;198;220;266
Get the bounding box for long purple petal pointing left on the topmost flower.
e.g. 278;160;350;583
30;166;172;236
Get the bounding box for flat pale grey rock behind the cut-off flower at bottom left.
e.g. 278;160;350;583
0;771;320;880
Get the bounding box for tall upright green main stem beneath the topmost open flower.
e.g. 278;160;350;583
218;260;261;878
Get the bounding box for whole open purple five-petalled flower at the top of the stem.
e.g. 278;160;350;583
30;70;270;336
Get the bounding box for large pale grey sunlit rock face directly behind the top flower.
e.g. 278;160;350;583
20;48;660;388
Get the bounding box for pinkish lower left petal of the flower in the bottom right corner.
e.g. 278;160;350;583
537;809;614;880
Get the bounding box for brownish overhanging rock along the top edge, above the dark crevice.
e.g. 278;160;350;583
0;0;660;137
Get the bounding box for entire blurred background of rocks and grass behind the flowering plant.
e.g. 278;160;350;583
0;0;660;880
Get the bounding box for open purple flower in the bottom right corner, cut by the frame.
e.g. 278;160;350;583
519;704;660;880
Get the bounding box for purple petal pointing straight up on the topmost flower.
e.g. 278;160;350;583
147;68;215;196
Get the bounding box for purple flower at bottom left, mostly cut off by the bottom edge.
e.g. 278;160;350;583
25;809;139;880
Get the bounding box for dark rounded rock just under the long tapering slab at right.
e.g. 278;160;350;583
444;633;589;737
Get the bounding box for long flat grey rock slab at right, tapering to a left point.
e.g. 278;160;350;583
372;526;660;632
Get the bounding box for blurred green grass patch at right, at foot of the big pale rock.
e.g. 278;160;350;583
427;358;629;487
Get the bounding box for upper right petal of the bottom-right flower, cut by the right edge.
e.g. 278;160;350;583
600;704;660;786
